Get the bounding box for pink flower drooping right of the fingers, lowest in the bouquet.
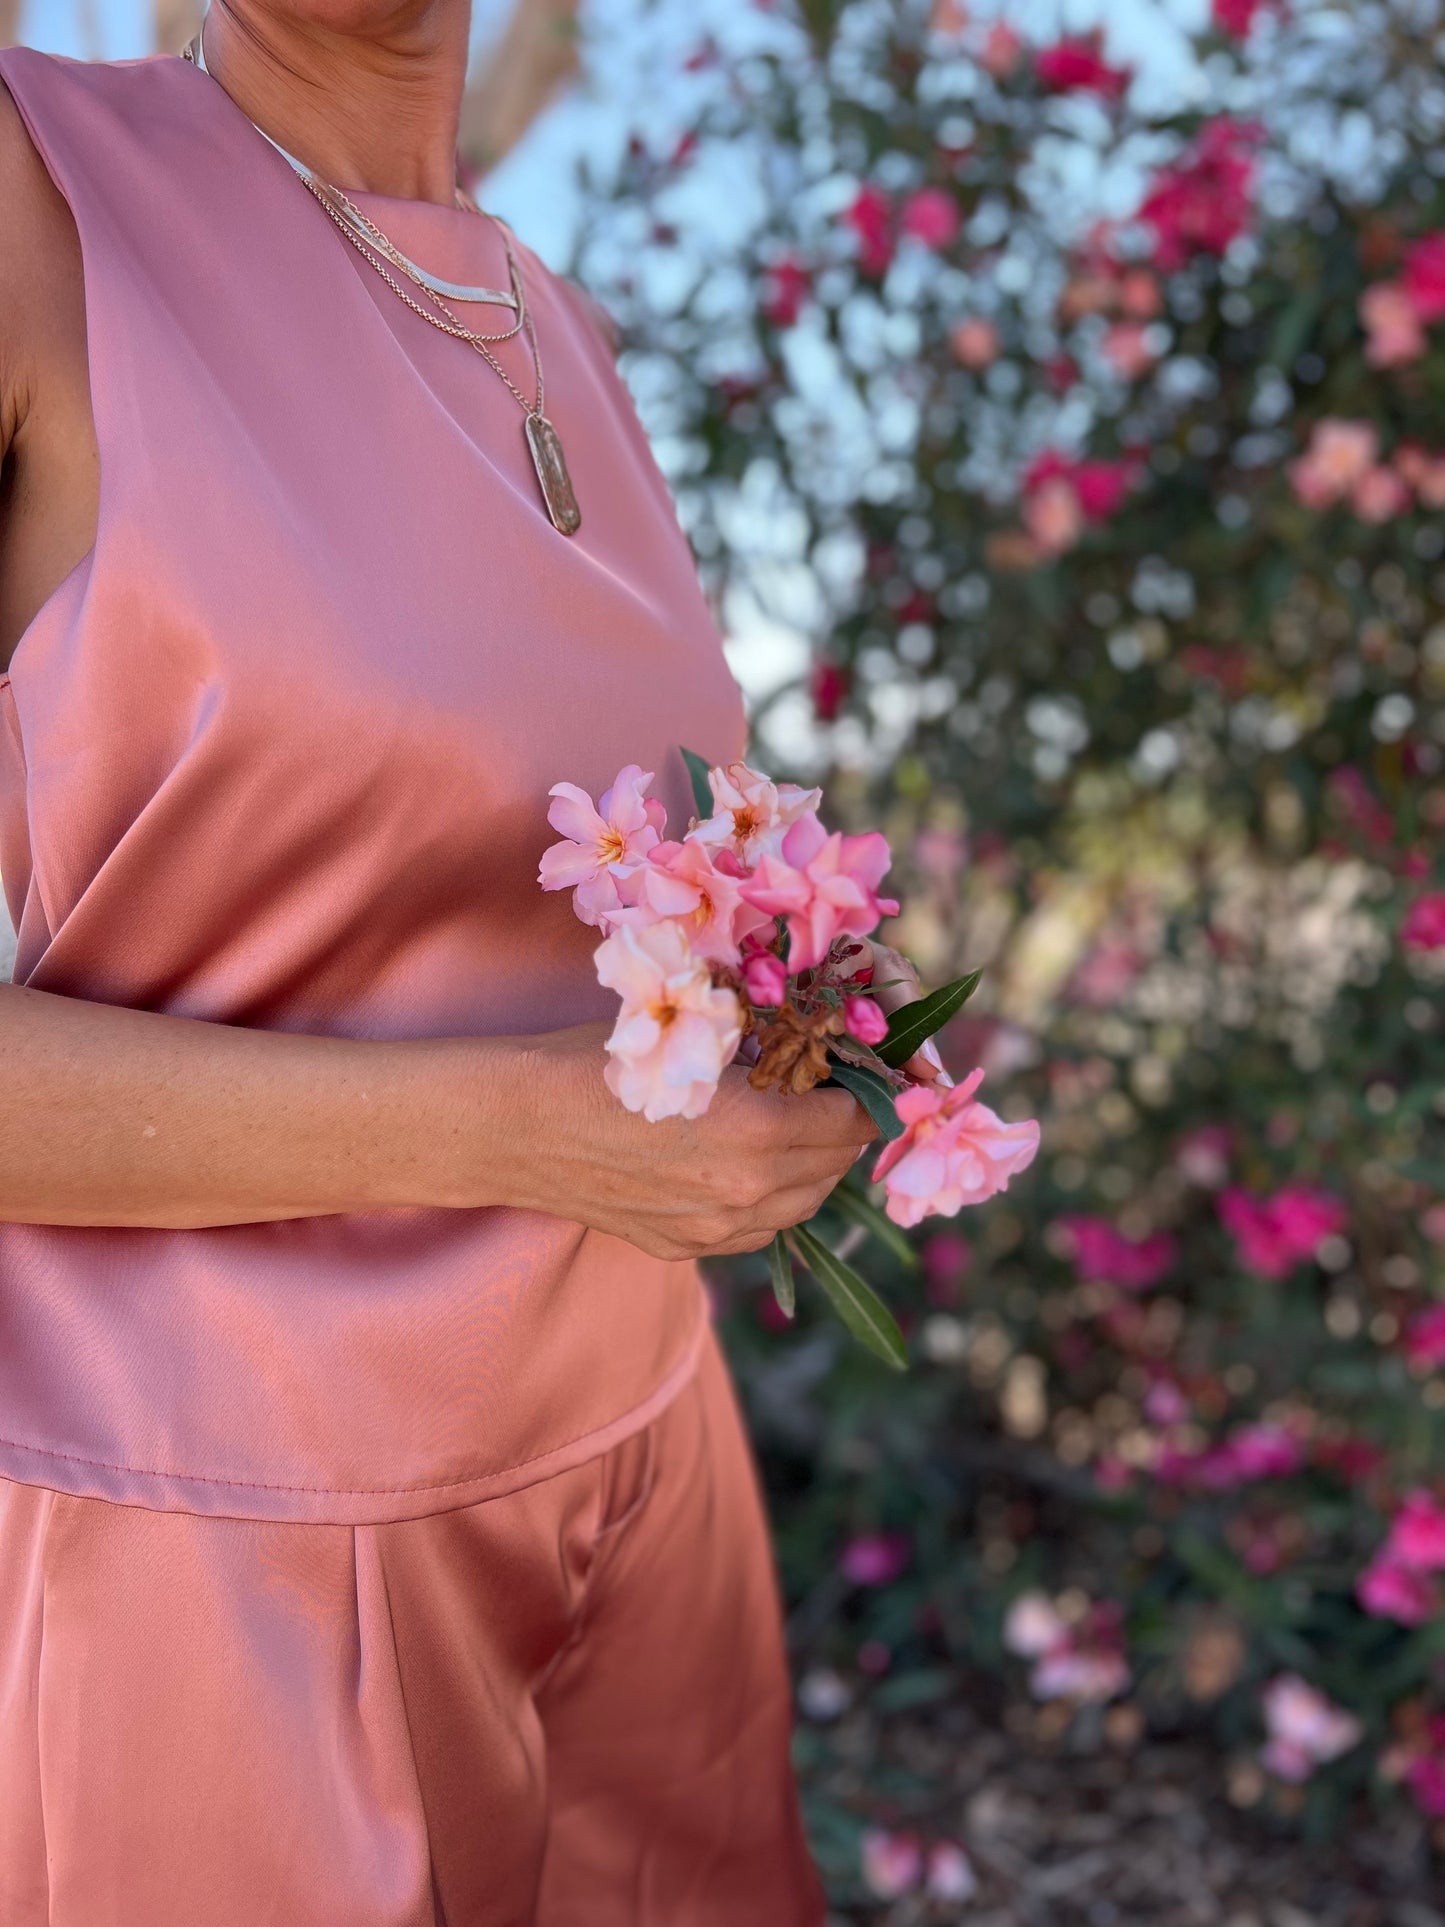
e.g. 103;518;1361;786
873;1069;1038;1226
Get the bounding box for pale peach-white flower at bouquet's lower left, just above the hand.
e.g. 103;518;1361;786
595;923;742;1123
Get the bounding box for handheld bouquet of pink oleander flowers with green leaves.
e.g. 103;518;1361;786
538;750;1038;1368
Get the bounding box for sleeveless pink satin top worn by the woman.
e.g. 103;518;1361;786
0;50;744;1522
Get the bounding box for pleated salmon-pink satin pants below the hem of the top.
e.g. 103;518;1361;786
0;1339;823;1927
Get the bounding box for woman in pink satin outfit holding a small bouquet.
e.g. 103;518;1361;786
0;0;940;1927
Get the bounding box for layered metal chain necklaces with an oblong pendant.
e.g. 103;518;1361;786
185;24;582;536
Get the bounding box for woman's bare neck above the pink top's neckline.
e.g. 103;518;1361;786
204;0;470;208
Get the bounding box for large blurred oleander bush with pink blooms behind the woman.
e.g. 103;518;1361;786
582;0;1445;1892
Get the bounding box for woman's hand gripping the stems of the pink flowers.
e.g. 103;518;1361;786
505;1023;877;1258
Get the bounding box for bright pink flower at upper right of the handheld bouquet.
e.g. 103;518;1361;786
744;813;898;973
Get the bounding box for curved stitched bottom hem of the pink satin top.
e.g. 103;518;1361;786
0;1293;711;1526
